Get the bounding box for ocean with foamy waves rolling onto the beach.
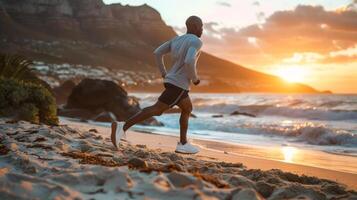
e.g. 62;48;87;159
129;93;357;173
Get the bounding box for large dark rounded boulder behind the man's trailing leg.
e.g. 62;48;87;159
61;79;162;125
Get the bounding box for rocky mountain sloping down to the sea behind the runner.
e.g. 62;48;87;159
0;0;318;93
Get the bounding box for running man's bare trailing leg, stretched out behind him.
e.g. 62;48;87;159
123;101;169;131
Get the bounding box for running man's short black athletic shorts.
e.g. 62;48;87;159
159;83;189;108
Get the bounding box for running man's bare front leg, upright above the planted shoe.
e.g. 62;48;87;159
177;97;192;144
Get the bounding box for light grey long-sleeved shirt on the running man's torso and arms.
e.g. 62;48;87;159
154;33;202;90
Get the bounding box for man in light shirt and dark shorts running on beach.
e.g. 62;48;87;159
111;16;203;154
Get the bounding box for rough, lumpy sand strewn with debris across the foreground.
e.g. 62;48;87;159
0;119;357;200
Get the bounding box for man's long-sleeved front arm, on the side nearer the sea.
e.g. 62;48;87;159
185;41;202;85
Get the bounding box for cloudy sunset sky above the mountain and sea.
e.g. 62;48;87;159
104;0;357;93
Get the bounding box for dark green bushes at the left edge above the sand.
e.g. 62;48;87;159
0;55;58;125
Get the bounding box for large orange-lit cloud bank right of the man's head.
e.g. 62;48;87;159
196;4;357;66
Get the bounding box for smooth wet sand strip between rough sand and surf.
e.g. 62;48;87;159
64;120;357;190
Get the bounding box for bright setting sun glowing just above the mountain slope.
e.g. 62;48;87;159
275;67;307;83
